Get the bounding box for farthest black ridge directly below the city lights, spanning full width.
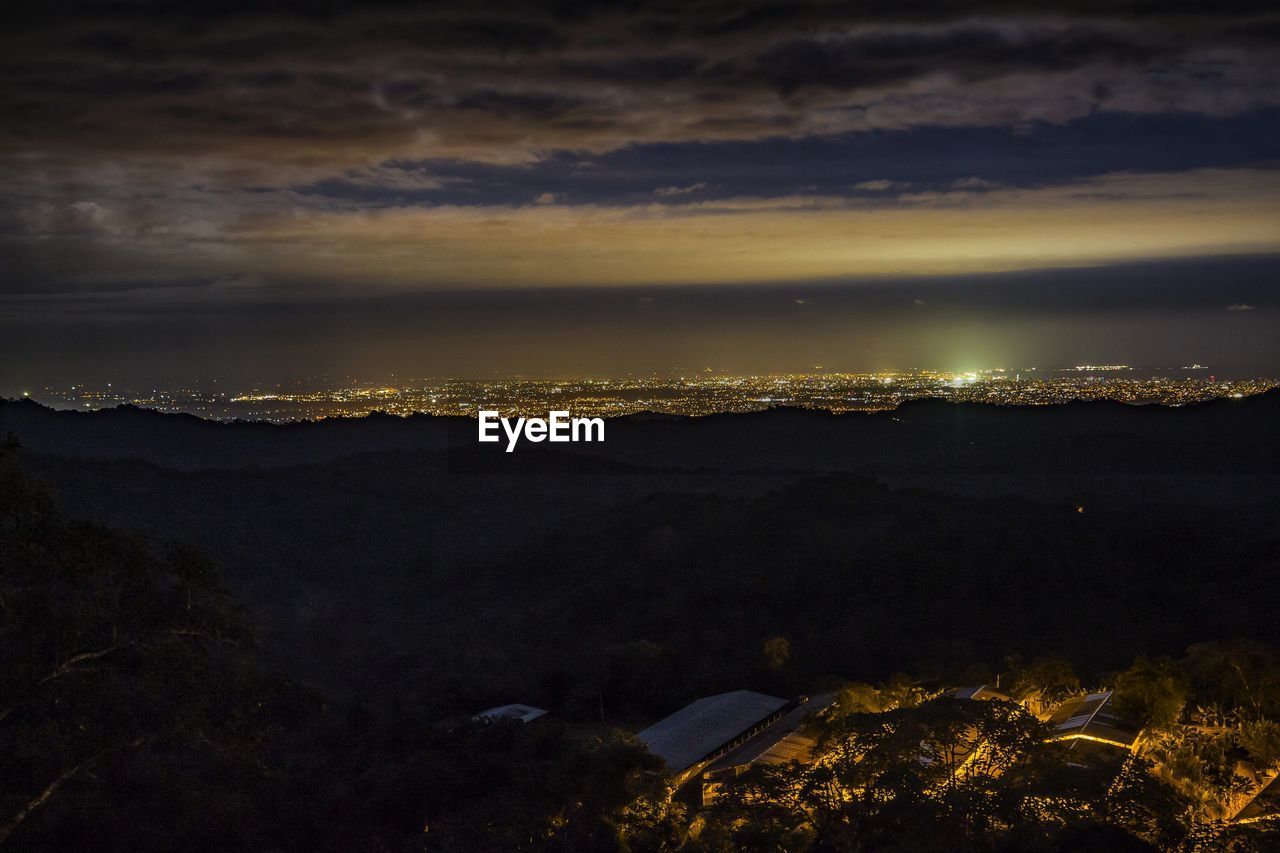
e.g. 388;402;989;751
0;392;1280;474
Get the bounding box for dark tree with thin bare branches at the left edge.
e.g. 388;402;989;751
0;443;309;849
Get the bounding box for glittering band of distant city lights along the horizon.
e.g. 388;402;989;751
23;364;1280;423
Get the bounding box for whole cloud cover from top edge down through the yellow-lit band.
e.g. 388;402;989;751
0;0;1280;302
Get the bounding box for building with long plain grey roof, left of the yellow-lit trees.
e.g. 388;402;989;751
636;690;791;788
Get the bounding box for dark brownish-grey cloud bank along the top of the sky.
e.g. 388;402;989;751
0;0;1280;161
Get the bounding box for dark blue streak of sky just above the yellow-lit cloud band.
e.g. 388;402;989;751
280;109;1280;205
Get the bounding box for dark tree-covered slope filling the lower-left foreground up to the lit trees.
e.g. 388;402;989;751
0;444;666;852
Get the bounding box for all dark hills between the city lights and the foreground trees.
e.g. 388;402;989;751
0;393;1280;701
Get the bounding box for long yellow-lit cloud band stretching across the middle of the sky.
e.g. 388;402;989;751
0;169;1280;298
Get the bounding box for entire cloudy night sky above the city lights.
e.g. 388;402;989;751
0;0;1280;396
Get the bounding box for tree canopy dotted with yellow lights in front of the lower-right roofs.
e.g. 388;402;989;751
692;699;1183;850
